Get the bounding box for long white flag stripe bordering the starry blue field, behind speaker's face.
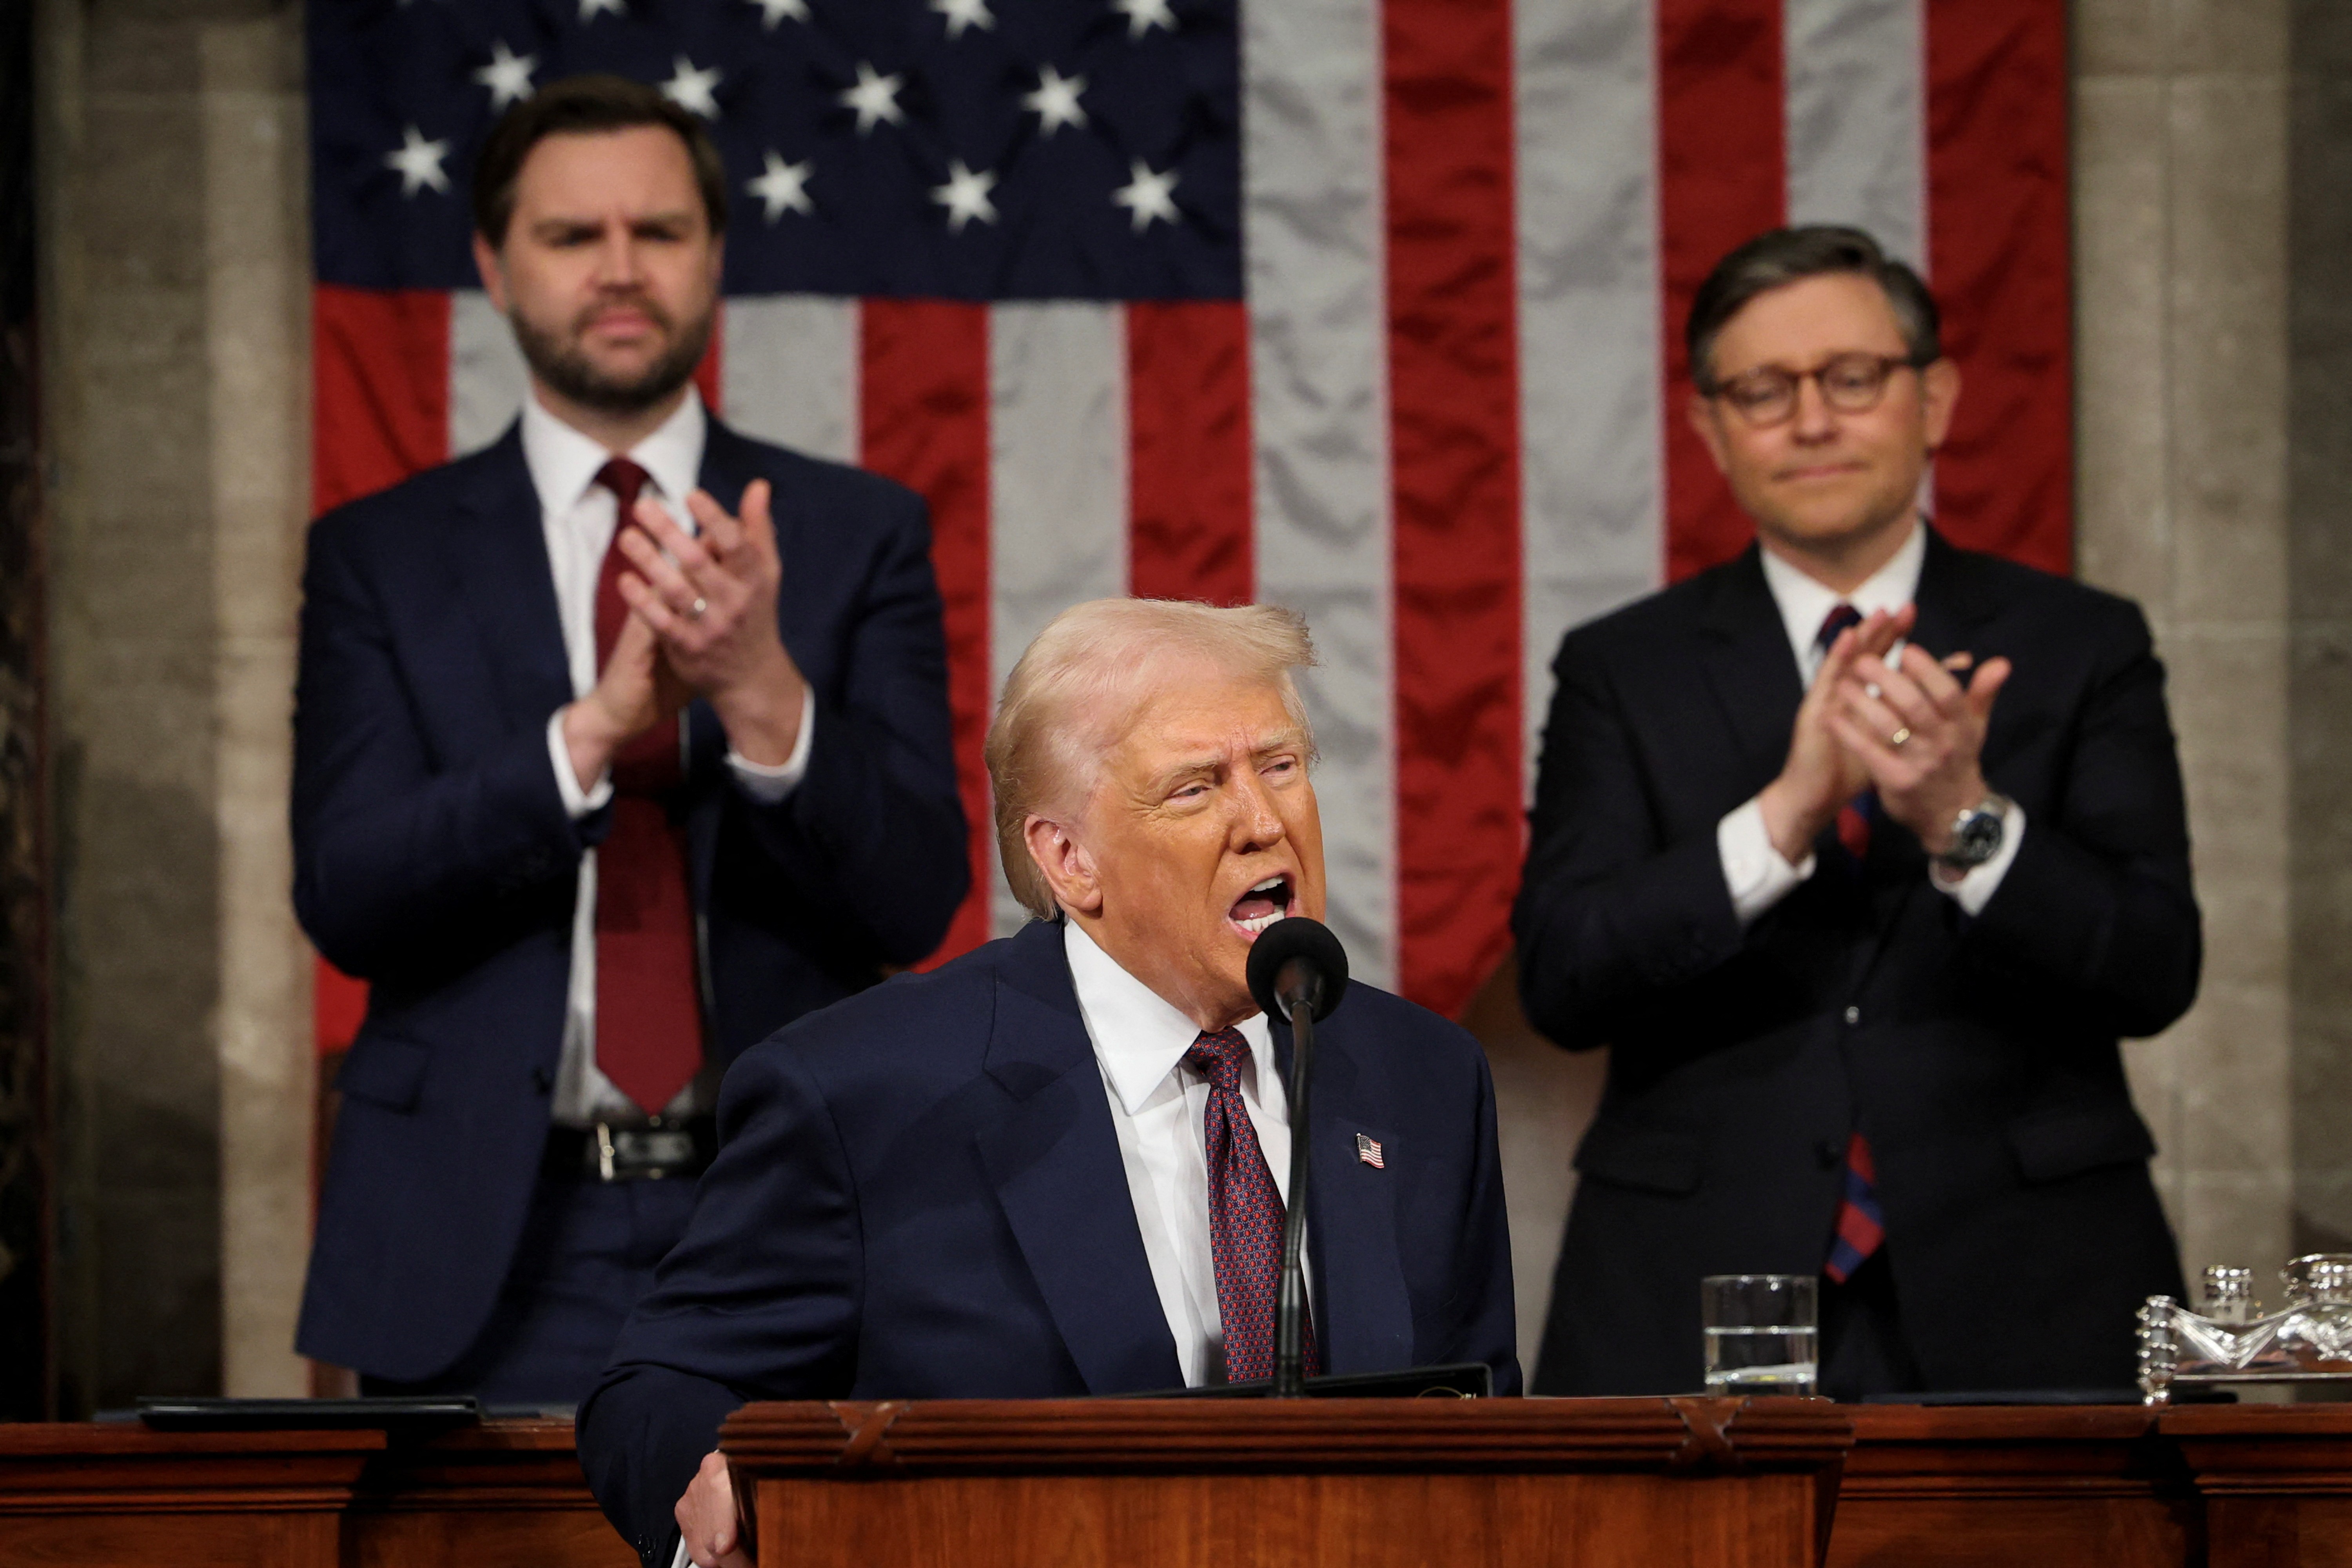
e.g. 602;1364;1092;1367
1242;0;1397;985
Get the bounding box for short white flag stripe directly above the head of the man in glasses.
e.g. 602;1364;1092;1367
1783;0;1929;270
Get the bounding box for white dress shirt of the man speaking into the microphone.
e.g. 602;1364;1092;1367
1063;919;1291;1387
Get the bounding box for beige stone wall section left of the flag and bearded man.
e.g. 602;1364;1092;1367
38;0;310;1410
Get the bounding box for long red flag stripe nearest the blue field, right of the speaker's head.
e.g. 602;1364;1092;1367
1383;0;1522;1013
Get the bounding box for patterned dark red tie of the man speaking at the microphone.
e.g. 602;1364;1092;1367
1183;1030;1319;1382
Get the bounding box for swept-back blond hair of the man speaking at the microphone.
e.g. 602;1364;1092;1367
985;599;1315;919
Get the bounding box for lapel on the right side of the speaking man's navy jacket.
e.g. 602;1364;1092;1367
1275;1020;1414;1373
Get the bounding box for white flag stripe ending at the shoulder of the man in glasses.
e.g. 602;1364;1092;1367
1512;0;1665;788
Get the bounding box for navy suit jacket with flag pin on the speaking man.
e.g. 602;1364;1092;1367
579;924;1519;1566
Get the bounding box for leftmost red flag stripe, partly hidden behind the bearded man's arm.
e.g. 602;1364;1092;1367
310;285;449;1053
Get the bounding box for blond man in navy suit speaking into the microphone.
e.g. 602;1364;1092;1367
579;599;1519;1568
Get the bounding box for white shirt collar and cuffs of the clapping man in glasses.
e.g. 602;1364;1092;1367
1715;522;2025;926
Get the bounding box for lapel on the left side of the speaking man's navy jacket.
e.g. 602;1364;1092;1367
978;924;1183;1394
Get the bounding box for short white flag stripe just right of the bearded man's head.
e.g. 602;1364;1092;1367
720;294;858;463
